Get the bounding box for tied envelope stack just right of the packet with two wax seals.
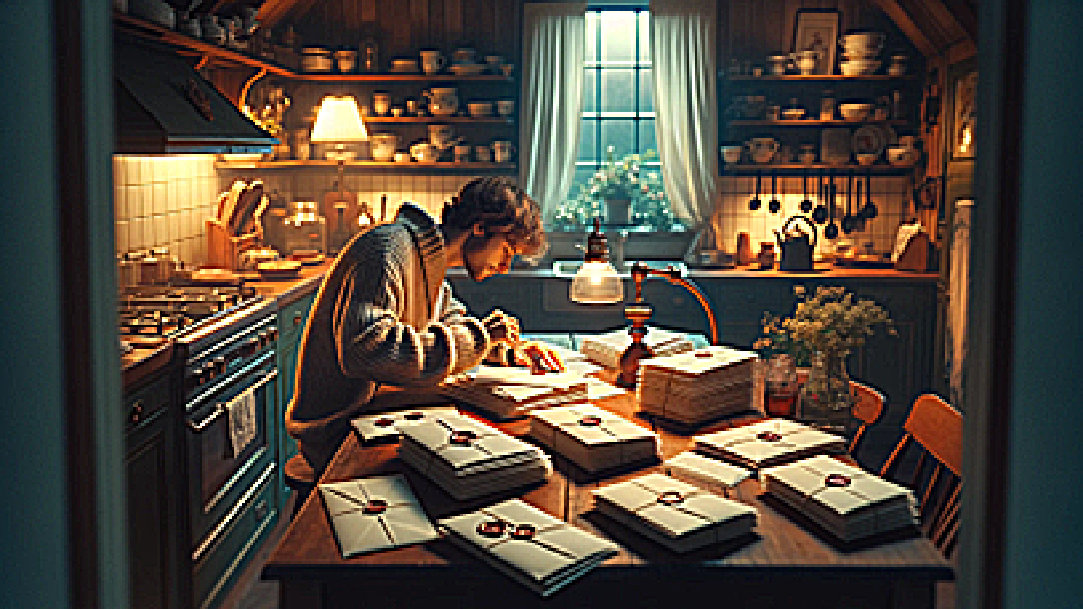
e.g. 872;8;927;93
591;474;756;553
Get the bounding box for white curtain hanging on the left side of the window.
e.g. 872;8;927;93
519;2;587;218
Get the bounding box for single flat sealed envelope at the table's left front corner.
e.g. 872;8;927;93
317;475;440;558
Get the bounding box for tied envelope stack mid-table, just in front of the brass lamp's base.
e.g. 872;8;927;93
531;404;661;472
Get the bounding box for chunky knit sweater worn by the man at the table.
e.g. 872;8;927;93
286;204;490;471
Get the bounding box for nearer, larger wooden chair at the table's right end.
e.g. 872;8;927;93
880;393;963;558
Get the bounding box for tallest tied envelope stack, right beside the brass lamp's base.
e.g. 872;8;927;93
636;346;756;425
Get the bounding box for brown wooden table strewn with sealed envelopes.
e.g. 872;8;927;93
263;370;953;609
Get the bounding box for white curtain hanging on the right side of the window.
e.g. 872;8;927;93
651;0;718;225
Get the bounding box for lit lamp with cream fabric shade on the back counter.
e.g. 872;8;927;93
310;95;368;251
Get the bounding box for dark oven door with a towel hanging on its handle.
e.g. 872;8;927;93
185;350;278;544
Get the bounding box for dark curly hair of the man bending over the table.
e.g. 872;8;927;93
443;177;546;256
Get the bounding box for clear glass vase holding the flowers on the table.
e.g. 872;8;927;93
798;351;853;436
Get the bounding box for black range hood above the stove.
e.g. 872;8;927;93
113;37;278;154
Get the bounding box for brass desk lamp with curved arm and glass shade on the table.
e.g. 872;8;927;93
569;219;718;389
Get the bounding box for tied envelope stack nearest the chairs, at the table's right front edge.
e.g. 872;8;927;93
762;455;917;542
